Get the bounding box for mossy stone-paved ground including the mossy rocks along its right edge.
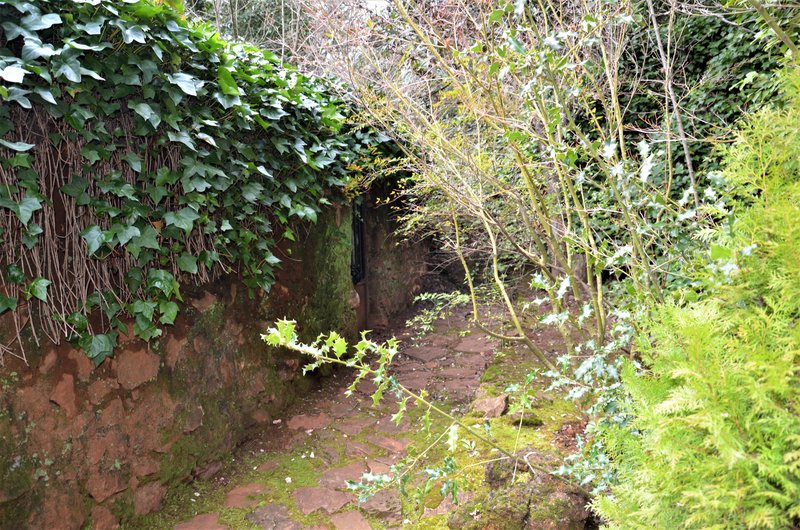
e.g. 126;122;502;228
138;306;587;530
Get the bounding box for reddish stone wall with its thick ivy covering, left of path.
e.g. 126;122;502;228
0;0;396;530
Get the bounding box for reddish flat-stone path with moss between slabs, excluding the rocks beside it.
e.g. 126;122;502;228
136;313;574;530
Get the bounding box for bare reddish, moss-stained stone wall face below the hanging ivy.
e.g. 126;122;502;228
0;203;356;530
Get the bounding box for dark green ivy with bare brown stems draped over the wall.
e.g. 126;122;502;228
0;0;386;363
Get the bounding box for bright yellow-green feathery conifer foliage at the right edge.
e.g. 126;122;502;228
595;71;800;529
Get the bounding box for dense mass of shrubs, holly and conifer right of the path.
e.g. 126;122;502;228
264;0;800;528
